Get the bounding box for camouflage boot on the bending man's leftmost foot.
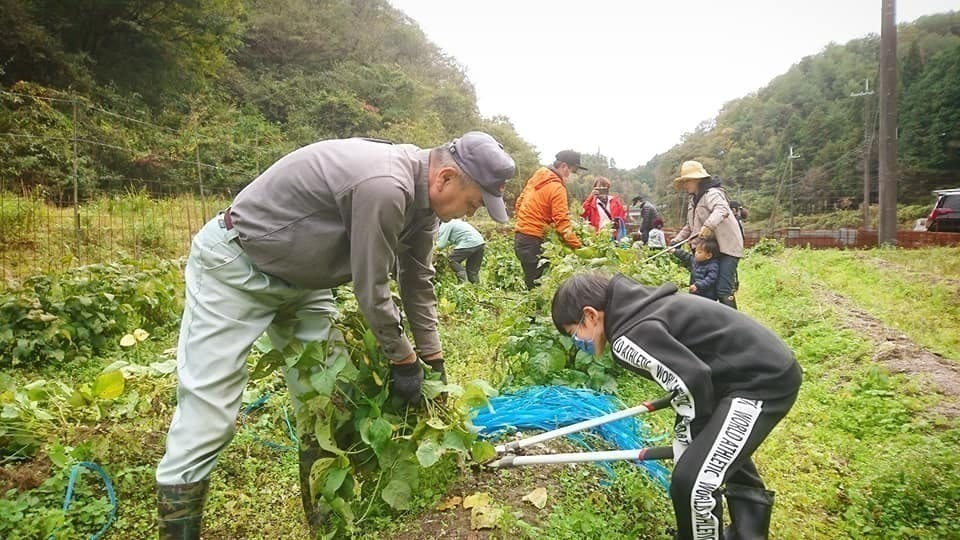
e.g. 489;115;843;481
157;480;210;540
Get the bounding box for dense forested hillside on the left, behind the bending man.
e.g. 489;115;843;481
0;0;537;201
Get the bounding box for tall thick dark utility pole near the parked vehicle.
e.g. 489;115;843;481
877;0;897;245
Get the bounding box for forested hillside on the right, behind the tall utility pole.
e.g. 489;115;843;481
630;12;960;224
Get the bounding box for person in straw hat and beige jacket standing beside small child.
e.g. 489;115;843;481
673;161;743;309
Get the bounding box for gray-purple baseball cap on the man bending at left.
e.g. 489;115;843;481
449;131;517;223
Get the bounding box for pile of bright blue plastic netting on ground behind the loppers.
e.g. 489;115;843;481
472;386;670;489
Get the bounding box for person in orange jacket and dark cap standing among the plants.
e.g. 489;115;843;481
513;150;587;289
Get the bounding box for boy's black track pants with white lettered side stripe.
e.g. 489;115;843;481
670;394;797;540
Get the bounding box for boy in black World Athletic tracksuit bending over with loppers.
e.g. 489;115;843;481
552;273;802;540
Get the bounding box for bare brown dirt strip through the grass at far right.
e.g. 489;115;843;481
819;289;960;418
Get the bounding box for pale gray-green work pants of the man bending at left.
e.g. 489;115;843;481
157;216;337;485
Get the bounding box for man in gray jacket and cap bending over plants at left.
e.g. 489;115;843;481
156;131;516;540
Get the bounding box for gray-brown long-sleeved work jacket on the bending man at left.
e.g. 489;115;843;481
231;139;441;360
